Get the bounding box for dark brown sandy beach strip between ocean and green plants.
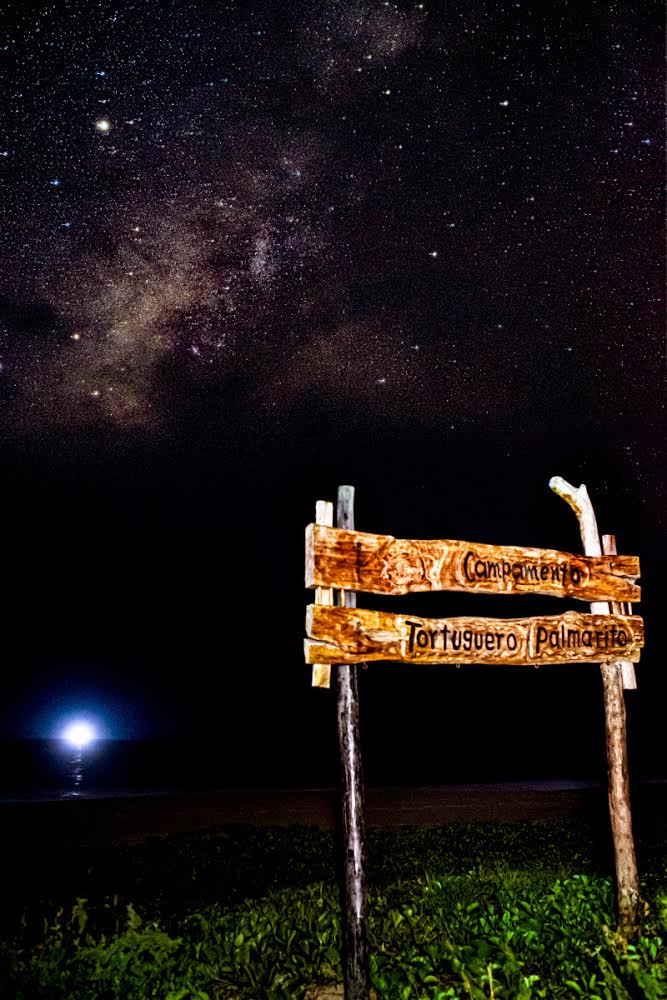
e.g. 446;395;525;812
0;782;667;851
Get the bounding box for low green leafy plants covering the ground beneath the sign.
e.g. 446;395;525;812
0;822;667;1000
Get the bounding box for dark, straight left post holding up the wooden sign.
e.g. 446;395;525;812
336;486;370;1000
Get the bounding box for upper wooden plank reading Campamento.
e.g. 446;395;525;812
306;524;641;602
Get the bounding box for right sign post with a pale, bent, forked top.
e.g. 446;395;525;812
549;476;641;939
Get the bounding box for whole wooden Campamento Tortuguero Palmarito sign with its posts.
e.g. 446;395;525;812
304;476;645;960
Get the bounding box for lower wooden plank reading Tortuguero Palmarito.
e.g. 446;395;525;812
305;604;644;664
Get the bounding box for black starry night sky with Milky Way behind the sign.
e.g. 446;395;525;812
0;0;667;784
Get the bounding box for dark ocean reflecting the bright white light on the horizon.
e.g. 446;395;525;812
0;739;665;802
